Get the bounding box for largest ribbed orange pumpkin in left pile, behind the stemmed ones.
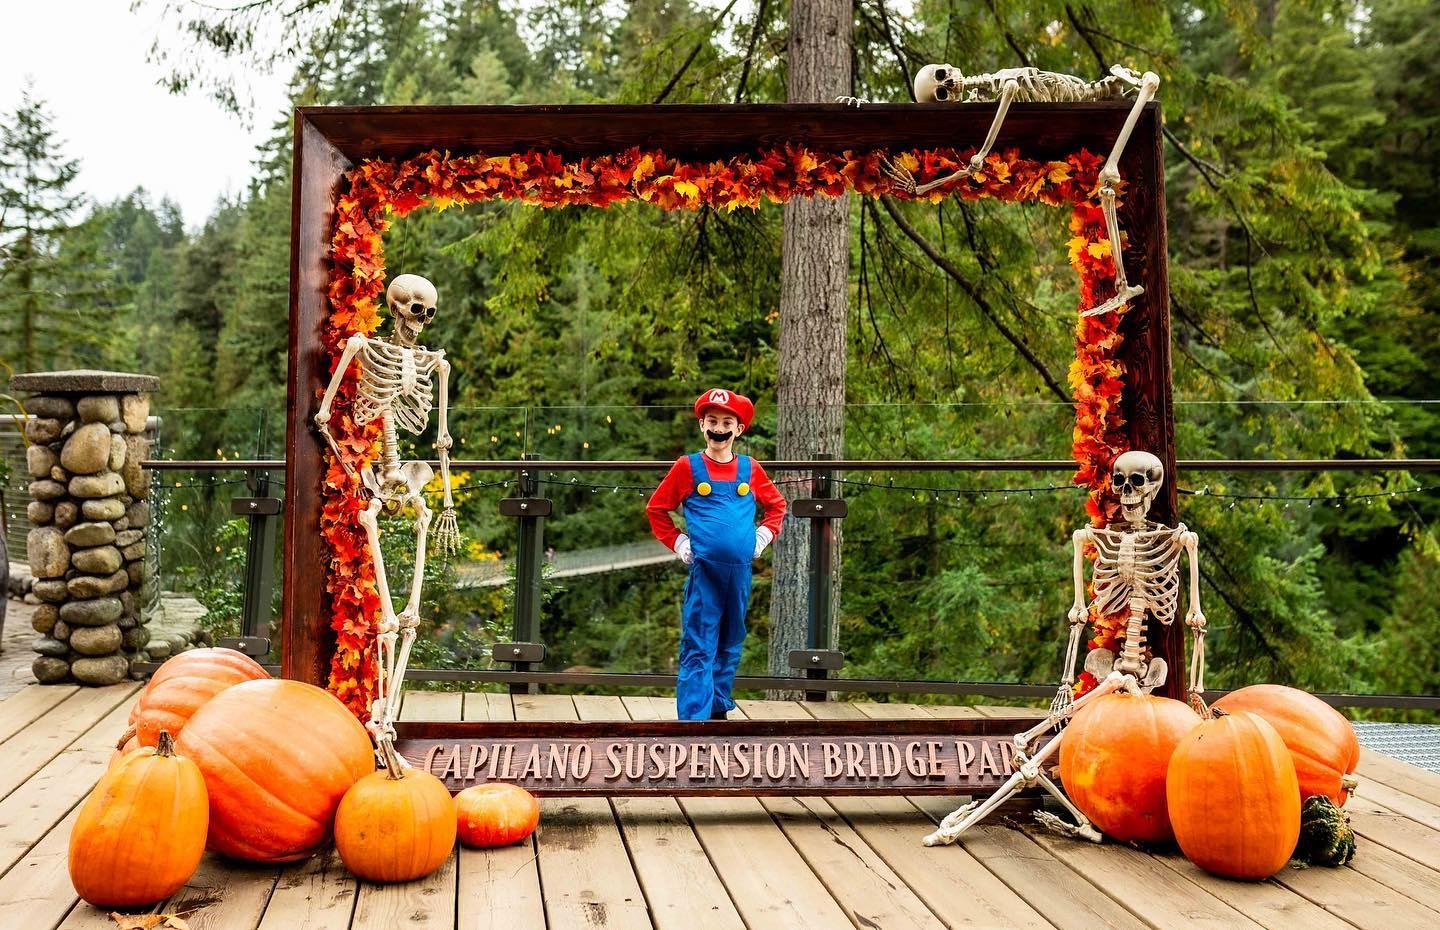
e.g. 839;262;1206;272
179;678;374;862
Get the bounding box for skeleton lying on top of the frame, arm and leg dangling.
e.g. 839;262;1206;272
864;65;1161;317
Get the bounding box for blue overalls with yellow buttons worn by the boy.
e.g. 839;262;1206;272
675;452;755;720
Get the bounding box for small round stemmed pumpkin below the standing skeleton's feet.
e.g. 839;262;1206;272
336;740;455;881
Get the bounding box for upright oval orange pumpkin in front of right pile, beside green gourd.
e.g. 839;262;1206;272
1165;711;1300;880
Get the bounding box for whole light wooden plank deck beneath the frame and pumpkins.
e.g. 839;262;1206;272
0;687;1440;930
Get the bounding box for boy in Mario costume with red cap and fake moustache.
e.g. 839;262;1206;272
645;387;785;720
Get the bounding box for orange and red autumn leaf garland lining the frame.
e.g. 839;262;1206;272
321;145;1125;720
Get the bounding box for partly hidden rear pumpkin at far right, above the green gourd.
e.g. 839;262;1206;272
1215;685;1359;806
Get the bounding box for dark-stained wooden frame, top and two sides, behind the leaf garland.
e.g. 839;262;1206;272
281;101;1185;697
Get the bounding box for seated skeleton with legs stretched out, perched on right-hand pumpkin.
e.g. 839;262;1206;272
924;452;1205;847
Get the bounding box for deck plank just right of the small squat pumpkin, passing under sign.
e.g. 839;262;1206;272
514;694;651;930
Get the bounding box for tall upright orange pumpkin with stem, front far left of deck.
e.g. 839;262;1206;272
69;733;209;907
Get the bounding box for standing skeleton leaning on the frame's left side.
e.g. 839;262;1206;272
315;275;459;764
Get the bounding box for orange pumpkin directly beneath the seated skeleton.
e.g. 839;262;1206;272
1060;692;1200;844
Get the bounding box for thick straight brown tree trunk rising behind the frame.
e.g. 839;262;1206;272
770;0;854;700
